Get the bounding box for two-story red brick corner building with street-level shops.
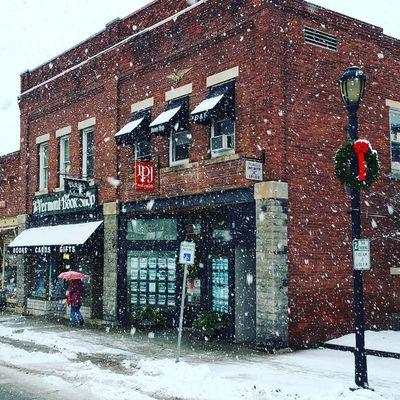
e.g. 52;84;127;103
8;0;400;346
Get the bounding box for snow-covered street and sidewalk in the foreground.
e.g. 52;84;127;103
0;315;400;400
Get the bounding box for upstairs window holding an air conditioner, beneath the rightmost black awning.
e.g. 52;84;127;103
211;117;236;157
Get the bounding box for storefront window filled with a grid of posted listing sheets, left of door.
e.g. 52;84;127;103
127;251;176;307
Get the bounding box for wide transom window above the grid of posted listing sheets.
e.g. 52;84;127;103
127;218;178;241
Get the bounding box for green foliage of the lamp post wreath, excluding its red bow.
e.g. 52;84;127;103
334;143;379;190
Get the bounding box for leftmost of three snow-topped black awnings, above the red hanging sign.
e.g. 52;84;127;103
115;110;151;145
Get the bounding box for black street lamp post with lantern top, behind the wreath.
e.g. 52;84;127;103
339;67;368;388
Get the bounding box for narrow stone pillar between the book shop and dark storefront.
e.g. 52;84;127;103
103;202;119;322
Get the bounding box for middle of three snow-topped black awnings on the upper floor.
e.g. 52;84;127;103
150;97;189;135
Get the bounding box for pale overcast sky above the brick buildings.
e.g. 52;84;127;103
0;0;400;155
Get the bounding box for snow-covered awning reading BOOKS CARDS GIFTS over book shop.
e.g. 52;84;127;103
7;221;103;254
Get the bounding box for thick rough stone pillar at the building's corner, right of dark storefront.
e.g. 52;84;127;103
254;181;289;348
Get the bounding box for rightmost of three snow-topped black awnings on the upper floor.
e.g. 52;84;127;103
191;81;235;125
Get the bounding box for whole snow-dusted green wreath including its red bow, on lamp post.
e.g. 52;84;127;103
334;139;379;190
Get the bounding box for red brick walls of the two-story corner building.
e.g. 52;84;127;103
20;0;400;345
